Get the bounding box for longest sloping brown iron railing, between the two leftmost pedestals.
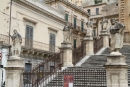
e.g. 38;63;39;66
23;51;63;87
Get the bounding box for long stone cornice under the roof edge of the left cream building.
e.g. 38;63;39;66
13;0;65;24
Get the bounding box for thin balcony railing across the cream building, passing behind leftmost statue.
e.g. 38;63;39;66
0;34;59;52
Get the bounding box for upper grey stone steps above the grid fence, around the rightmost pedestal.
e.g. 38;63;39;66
82;46;130;87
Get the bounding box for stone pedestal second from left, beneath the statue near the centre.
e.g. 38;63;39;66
60;42;73;67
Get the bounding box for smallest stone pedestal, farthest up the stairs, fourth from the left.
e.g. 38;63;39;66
100;30;109;48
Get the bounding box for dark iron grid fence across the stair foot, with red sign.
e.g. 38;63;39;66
23;68;106;87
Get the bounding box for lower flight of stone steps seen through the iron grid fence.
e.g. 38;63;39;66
45;67;106;87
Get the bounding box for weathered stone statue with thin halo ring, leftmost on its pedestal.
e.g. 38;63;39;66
11;29;22;57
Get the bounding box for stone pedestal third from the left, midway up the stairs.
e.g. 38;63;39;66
84;36;94;55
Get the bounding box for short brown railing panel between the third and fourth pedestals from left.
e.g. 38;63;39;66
94;37;103;53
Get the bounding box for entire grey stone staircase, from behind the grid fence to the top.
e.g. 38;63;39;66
45;46;130;87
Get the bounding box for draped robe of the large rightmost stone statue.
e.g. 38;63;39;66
110;24;124;51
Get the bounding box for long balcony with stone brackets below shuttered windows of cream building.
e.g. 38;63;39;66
0;34;60;56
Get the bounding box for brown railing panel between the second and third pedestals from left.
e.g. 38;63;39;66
73;43;86;65
